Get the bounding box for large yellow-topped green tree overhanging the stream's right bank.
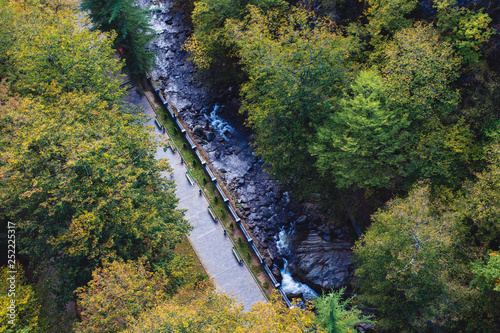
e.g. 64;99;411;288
229;7;348;191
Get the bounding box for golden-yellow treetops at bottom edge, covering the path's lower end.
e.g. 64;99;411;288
125;288;323;333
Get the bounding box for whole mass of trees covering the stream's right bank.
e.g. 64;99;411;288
187;0;500;332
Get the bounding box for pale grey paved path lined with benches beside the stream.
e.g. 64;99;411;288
127;88;266;310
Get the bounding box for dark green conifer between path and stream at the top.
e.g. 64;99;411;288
82;0;154;77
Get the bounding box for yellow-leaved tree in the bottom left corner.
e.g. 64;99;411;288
0;264;40;333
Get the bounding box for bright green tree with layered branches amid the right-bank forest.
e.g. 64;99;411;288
311;71;411;188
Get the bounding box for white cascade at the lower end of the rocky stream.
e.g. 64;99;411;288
276;229;318;300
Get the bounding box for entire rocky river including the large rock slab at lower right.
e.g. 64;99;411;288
140;0;354;298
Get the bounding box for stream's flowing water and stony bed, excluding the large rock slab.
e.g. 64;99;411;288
138;0;348;299
